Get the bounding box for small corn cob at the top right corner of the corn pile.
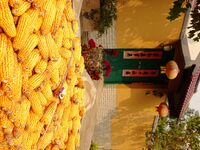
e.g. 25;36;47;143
64;2;76;21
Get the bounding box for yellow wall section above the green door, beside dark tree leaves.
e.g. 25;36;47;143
116;0;183;48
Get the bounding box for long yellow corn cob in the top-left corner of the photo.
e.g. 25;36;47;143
0;0;16;37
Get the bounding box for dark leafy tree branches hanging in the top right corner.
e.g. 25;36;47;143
167;0;200;42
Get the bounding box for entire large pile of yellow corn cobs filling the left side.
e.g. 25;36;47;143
0;0;84;150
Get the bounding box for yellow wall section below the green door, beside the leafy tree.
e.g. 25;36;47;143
112;85;165;150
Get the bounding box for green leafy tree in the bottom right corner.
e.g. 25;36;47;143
146;109;200;150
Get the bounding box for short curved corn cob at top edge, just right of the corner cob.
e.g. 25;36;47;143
12;1;31;16
